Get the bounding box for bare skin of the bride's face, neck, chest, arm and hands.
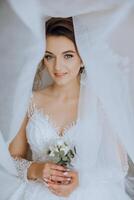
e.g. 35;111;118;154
9;36;82;197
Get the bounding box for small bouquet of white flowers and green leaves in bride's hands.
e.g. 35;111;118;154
47;138;76;167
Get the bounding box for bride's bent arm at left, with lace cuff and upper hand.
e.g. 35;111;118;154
9;112;69;183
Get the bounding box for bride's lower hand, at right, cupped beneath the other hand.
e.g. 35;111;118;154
48;171;79;197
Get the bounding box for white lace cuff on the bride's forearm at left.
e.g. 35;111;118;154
12;157;32;182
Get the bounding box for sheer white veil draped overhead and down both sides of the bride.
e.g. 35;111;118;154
0;0;134;200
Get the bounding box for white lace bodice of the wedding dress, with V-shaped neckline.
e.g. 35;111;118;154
26;95;79;161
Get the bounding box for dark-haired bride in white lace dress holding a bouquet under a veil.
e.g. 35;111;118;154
9;17;130;200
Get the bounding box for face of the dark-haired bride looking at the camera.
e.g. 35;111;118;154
44;36;82;85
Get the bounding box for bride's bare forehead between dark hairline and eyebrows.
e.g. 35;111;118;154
46;36;76;54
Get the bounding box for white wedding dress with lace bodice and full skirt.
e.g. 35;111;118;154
10;94;130;200
